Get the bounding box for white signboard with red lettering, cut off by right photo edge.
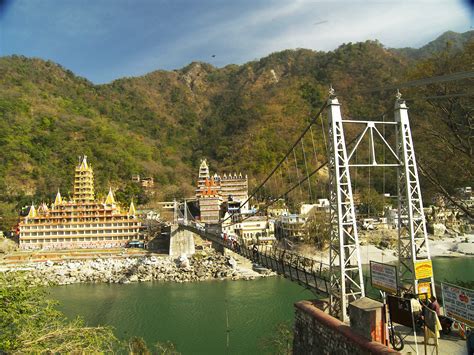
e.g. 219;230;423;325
441;282;474;327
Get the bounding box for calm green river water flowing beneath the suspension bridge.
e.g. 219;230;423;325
51;258;474;354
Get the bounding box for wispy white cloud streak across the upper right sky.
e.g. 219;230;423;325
126;0;469;79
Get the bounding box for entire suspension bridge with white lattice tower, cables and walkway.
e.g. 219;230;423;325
173;82;470;321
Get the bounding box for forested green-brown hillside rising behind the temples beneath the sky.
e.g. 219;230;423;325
0;31;474;229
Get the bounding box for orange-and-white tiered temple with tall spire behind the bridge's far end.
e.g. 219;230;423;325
196;159;248;224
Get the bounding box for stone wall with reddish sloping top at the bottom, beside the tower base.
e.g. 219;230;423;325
293;301;399;355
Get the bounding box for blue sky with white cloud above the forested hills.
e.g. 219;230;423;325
0;0;473;83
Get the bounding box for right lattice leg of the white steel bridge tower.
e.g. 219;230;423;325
395;93;435;295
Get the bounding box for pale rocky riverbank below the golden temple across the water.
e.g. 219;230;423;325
9;252;270;285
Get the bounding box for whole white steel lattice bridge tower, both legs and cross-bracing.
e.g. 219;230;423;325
328;88;435;321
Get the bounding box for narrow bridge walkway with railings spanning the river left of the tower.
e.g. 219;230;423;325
180;224;329;296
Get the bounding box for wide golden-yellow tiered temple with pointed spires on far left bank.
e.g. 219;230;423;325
19;156;140;250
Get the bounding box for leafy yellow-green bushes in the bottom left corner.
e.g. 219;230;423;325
0;273;119;354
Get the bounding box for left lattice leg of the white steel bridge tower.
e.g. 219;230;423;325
328;88;365;321
